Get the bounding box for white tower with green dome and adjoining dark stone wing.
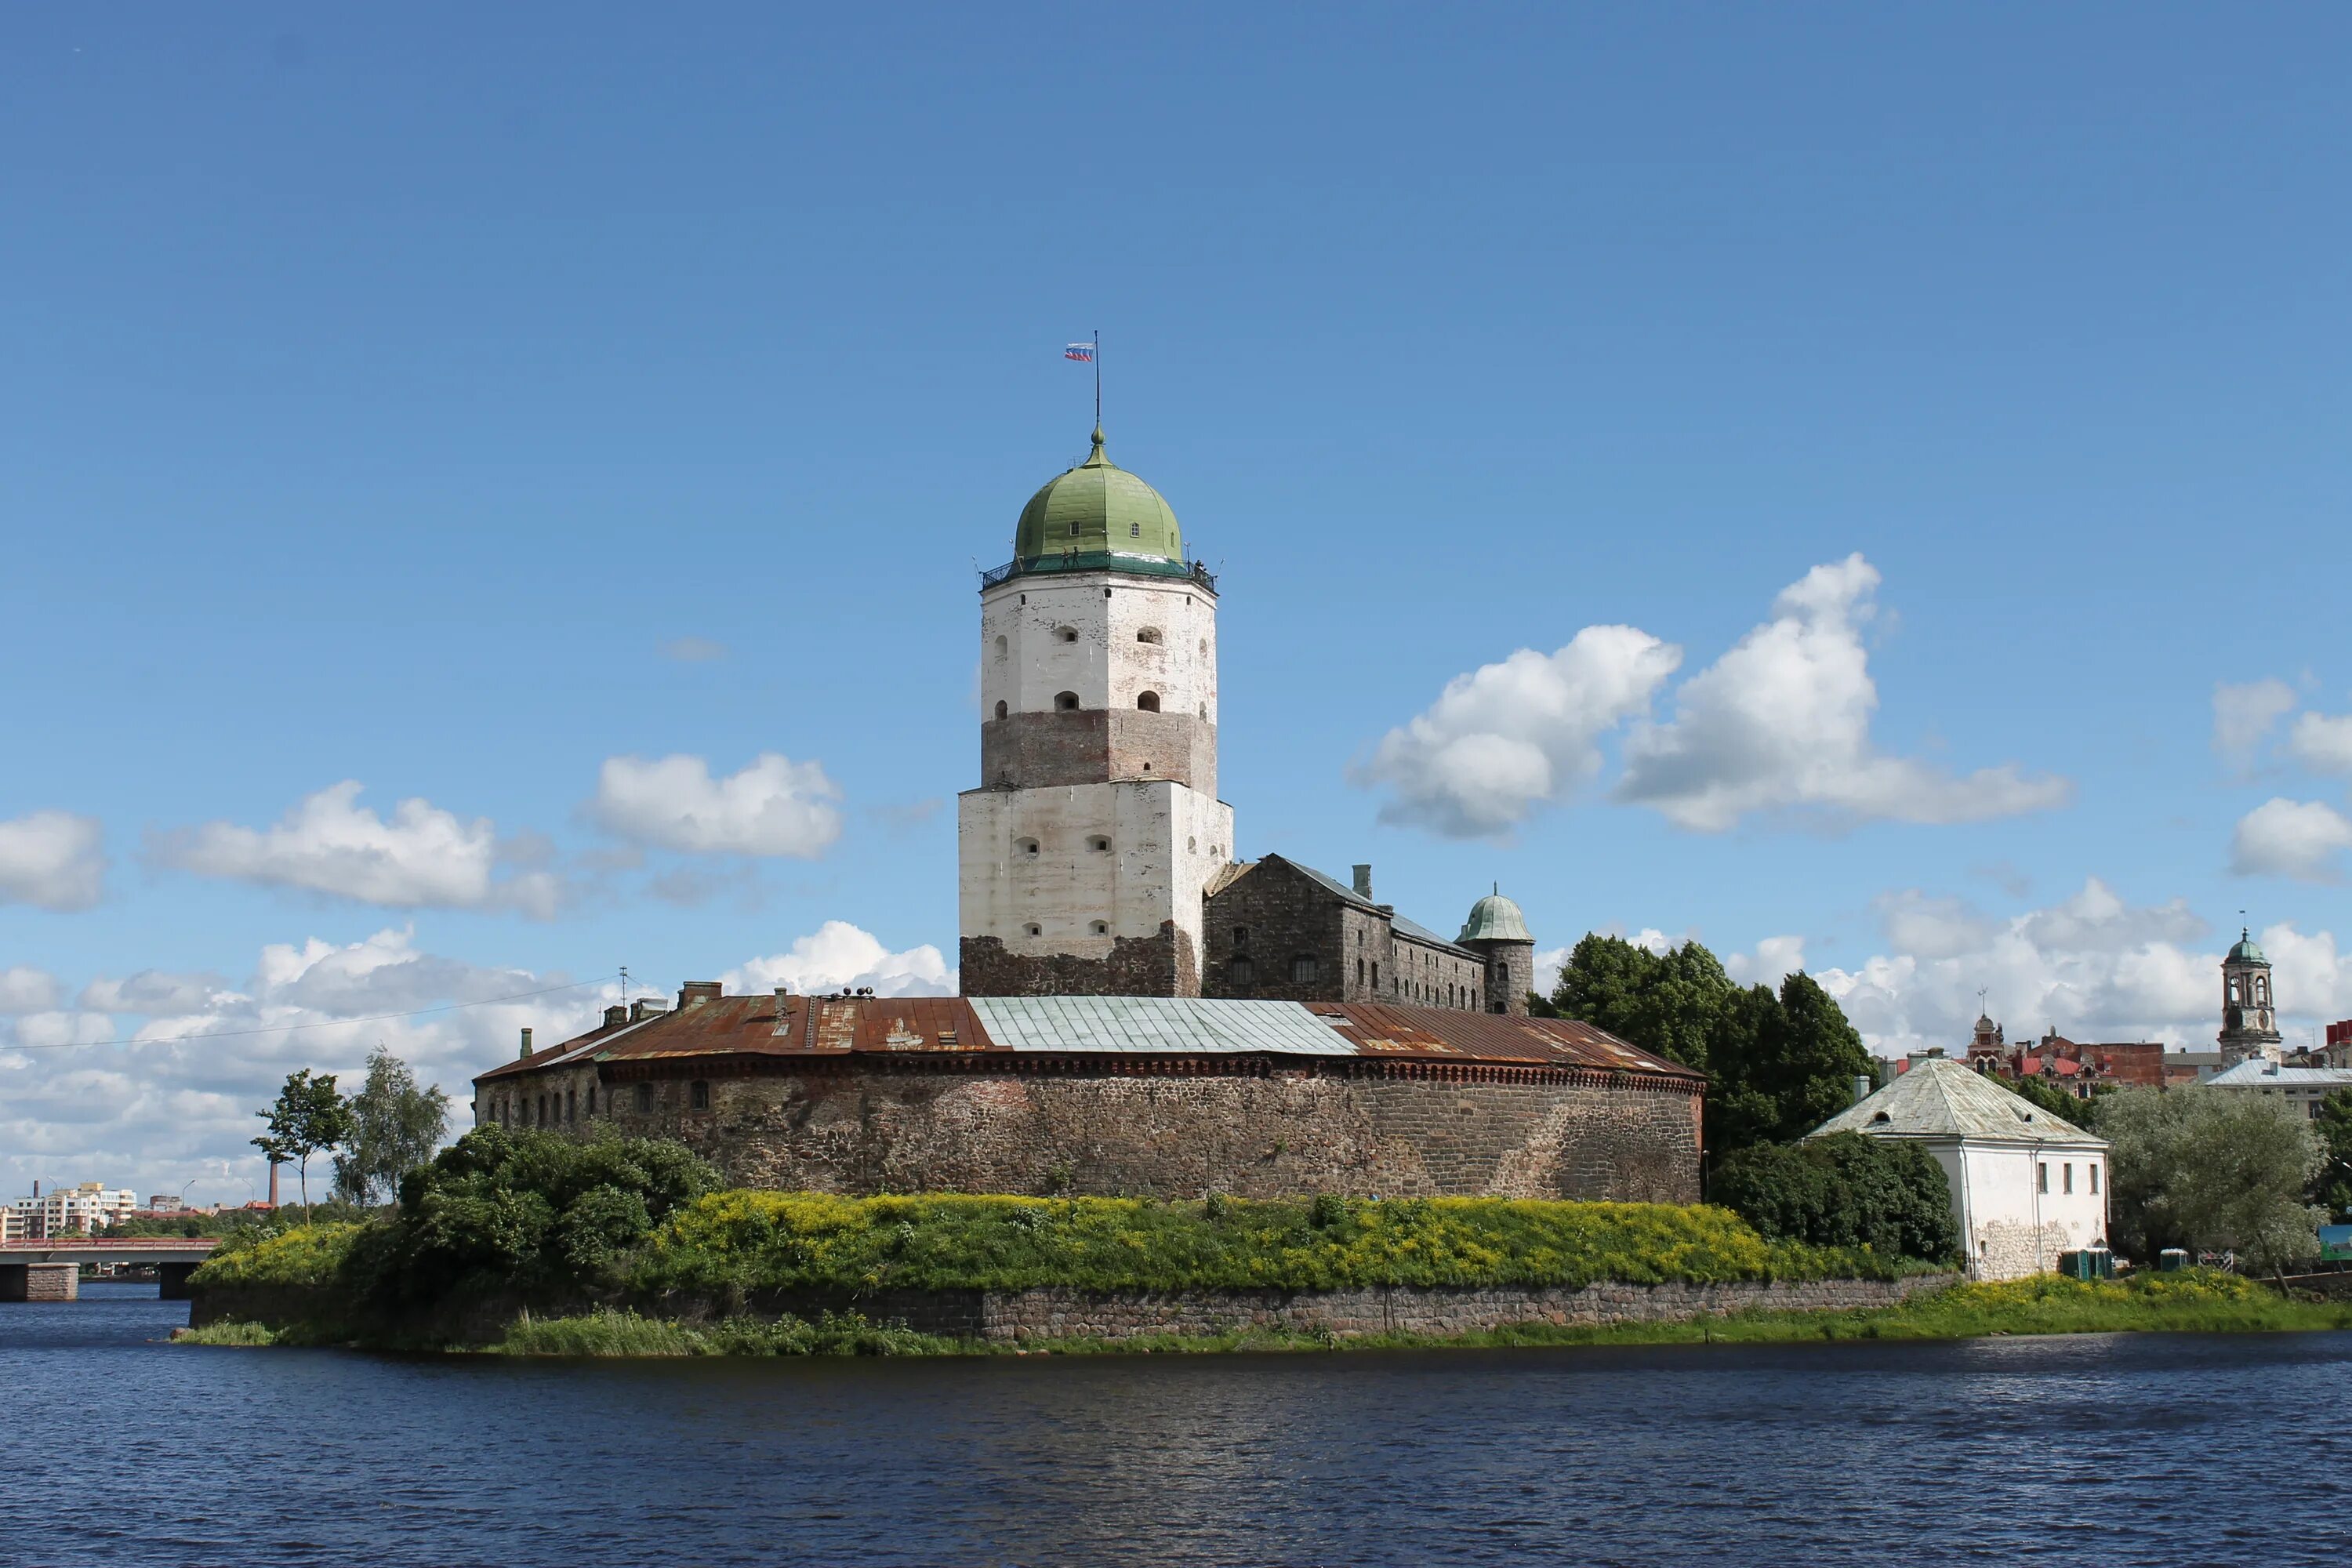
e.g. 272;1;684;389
957;430;1536;1013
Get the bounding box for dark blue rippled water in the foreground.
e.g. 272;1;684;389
0;1286;2352;1568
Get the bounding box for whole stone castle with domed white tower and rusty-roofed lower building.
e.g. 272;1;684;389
473;430;1703;1201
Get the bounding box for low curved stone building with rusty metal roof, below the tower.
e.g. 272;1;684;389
473;982;1705;1203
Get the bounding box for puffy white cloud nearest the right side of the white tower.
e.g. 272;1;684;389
1355;626;1682;837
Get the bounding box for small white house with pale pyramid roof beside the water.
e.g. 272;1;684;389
1811;1055;2110;1279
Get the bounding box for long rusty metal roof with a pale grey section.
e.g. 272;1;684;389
475;994;1698;1083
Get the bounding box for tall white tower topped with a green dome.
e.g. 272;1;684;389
957;430;1232;996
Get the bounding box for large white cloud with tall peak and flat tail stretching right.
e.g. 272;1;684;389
1616;555;2072;832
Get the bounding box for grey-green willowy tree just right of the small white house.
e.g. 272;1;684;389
2098;1088;2326;1272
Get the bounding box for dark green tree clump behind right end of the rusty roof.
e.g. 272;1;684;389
1552;935;1872;1152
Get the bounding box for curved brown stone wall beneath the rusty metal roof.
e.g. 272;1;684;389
581;1058;1698;1203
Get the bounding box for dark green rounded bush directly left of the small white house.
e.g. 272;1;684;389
1708;1133;1959;1262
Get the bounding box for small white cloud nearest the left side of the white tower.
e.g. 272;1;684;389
588;753;842;858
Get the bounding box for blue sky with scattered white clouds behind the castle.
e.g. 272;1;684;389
0;5;2352;1196
